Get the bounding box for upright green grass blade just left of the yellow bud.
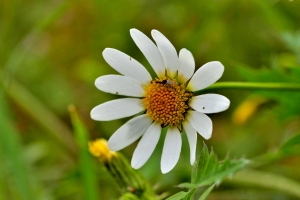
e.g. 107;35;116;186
69;106;99;200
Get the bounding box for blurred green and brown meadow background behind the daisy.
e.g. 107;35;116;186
0;0;300;200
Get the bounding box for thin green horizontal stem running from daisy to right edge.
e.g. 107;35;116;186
194;82;300;94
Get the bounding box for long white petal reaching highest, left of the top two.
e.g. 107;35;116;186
130;29;165;78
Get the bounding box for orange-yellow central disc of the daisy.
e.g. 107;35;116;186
144;78;193;127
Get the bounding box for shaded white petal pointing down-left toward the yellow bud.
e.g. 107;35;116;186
108;114;152;151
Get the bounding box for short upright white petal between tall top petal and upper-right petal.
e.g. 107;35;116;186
178;49;195;83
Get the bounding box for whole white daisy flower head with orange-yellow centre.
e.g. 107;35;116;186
91;29;230;173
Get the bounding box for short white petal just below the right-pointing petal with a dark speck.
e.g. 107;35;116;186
186;110;212;140
